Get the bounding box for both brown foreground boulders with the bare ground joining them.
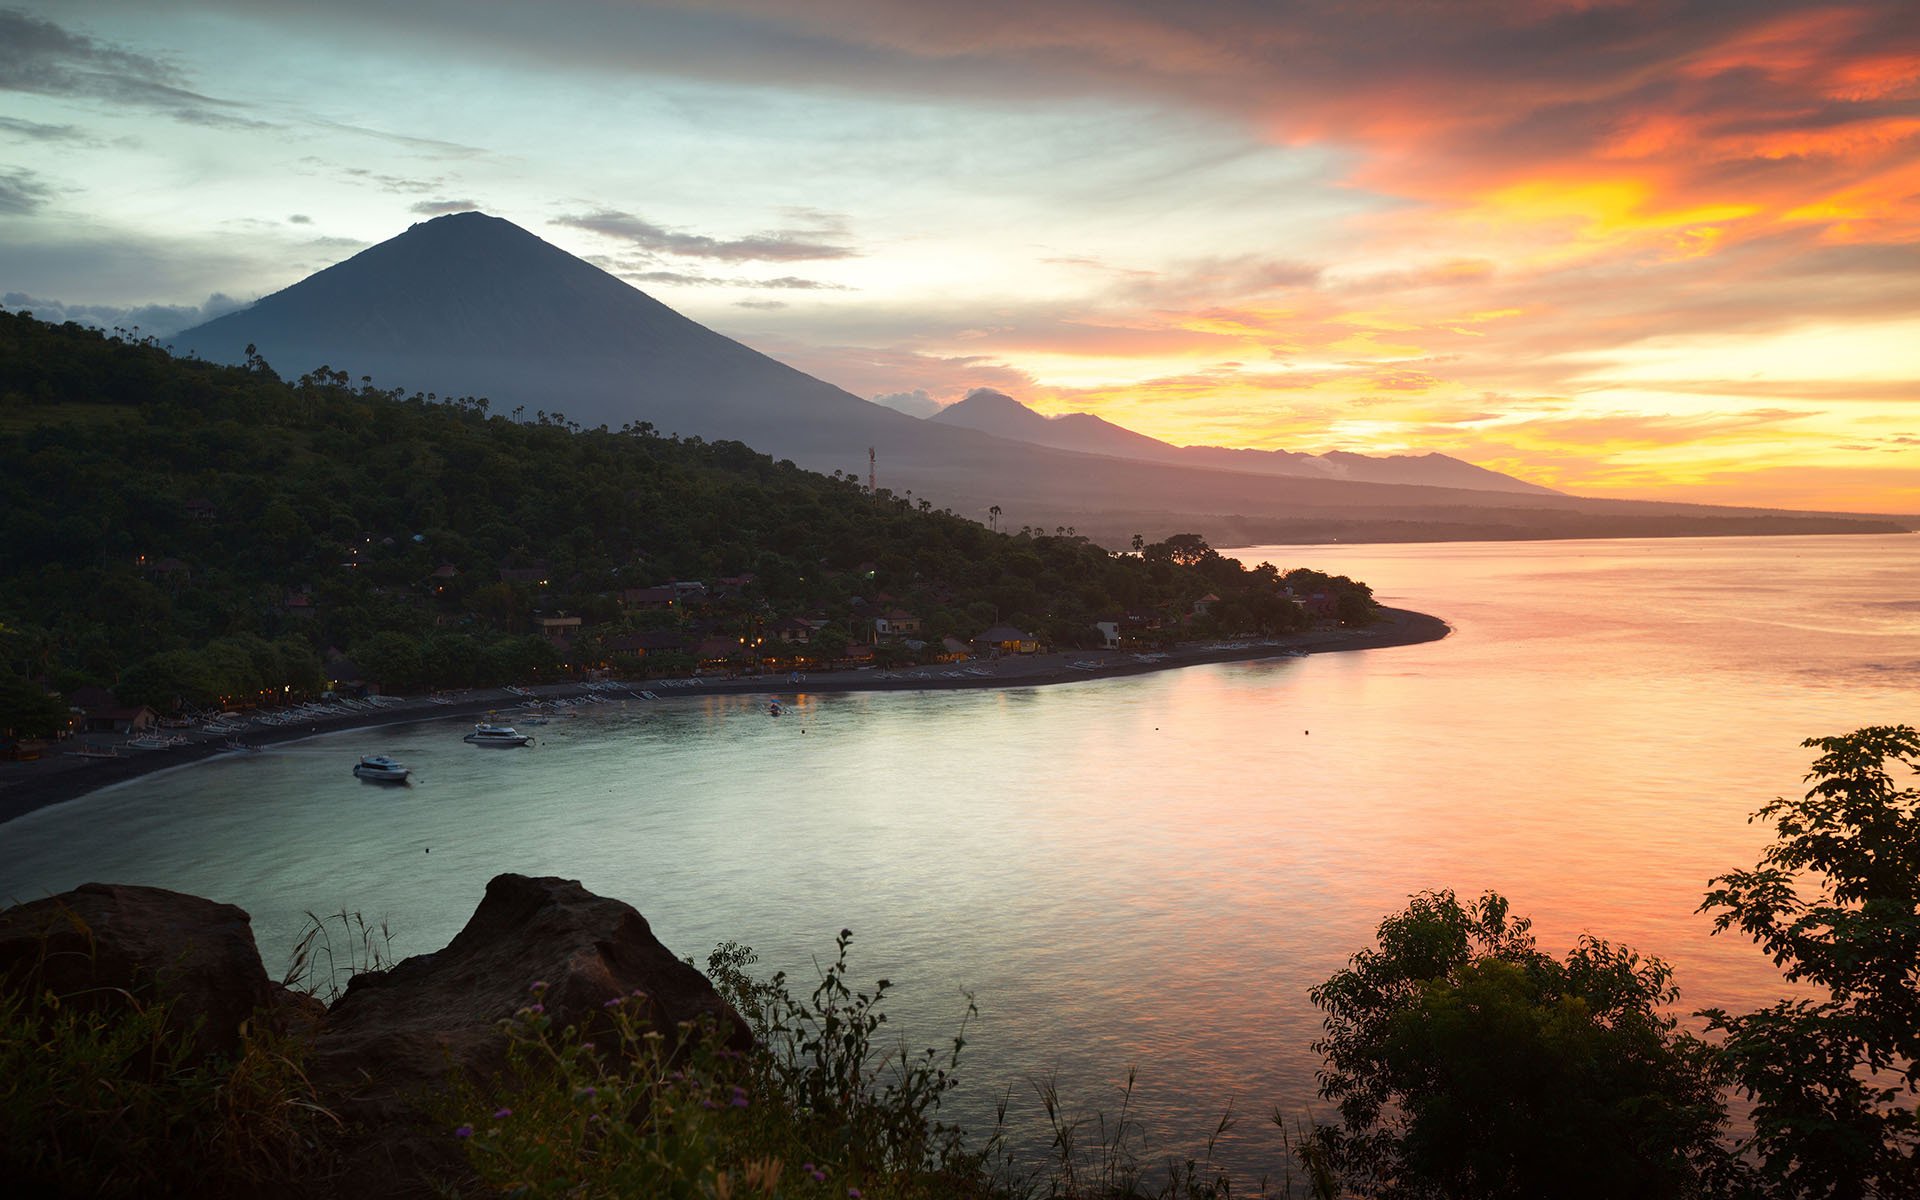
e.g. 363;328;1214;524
0;876;751;1200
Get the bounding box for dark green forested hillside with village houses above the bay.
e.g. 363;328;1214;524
0;315;1367;721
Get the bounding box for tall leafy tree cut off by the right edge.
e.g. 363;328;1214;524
1701;726;1920;1200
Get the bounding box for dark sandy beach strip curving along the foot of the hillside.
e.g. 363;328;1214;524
0;609;1452;824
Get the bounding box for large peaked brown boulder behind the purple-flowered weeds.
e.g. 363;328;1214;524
311;876;751;1125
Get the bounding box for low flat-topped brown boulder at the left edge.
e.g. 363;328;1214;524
0;883;276;1058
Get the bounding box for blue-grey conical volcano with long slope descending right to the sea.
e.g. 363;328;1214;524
173;213;1903;545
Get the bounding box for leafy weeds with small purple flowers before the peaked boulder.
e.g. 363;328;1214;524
453;933;991;1200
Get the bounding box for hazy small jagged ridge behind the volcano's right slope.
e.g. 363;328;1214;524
927;388;1565;495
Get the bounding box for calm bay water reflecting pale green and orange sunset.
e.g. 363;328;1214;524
0;538;1920;1169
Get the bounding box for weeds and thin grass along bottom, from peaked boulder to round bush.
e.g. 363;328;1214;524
445;931;1336;1200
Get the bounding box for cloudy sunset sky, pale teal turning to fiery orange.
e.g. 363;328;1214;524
0;0;1920;513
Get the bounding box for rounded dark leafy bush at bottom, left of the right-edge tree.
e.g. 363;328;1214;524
1311;891;1736;1200
